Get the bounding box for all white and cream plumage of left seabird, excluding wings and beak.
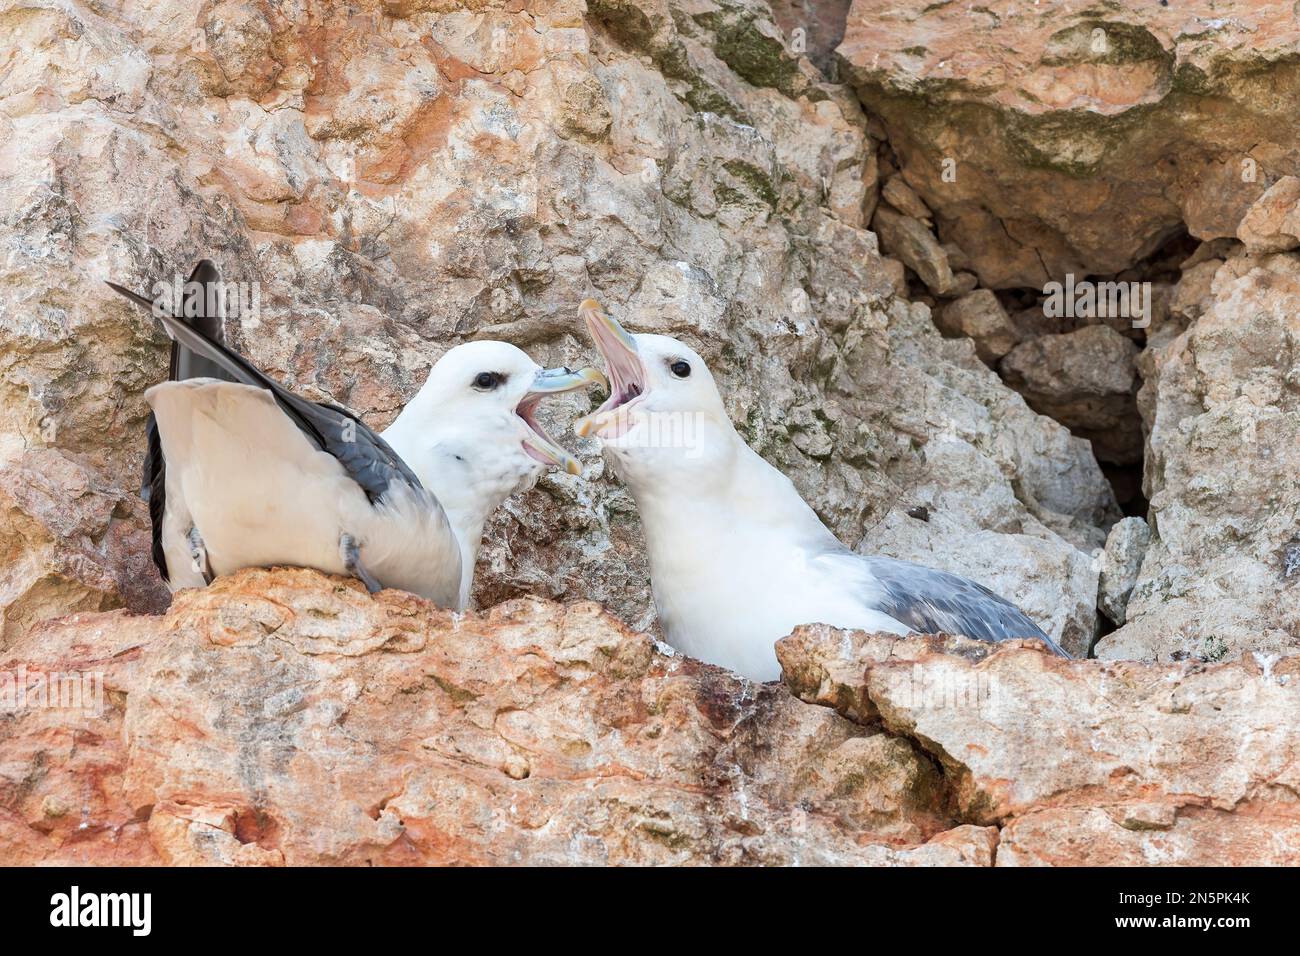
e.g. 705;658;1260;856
146;342;564;610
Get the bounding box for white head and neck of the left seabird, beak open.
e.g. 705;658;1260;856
384;341;607;580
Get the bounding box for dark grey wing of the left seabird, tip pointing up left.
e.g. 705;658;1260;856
108;282;421;502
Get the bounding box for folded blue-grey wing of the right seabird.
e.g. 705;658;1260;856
859;555;1070;657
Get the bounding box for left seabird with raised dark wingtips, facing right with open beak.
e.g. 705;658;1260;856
109;261;605;610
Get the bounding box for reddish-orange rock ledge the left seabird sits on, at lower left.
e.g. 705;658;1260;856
0;570;977;866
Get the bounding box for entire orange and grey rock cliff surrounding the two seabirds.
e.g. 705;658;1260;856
0;0;1300;865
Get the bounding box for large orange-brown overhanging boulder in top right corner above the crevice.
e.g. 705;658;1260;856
839;0;1300;289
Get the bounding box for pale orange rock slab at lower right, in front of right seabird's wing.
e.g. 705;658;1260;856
777;626;1300;865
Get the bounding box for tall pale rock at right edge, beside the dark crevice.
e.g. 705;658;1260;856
1097;254;1300;661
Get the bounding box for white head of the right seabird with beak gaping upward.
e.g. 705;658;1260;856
573;299;749;501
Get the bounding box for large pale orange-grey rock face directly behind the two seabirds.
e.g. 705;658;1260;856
0;0;1117;650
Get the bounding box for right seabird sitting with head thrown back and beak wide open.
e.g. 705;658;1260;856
575;299;1069;680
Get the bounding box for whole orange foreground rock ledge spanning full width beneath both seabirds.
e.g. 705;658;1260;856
0;570;1300;866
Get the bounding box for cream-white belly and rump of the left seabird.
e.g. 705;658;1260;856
146;378;460;606
